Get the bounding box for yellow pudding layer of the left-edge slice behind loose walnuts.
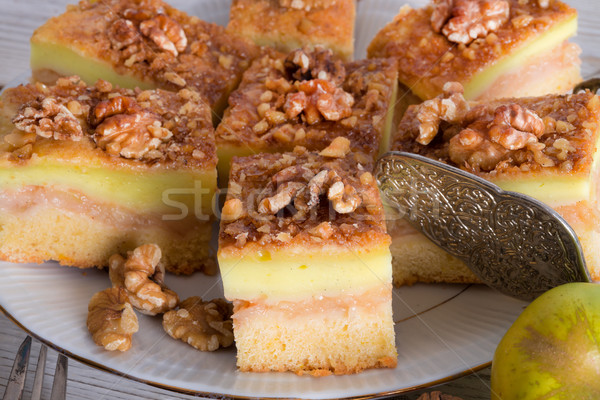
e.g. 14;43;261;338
0;163;217;215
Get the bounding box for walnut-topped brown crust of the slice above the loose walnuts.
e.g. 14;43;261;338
0;77;217;170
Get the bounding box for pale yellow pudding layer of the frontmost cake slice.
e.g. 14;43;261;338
218;243;391;303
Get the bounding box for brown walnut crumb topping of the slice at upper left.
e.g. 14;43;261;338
34;0;259;106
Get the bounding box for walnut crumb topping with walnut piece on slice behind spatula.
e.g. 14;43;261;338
392;85;600;175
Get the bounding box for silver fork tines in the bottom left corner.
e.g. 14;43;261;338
2;336;68;400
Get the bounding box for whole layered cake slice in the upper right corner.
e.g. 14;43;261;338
368;0;581;100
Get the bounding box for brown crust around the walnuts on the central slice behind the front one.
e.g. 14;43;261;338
216;47;397;157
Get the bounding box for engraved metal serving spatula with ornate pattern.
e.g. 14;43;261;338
376;152;591;300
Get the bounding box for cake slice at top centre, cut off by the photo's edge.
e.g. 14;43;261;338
227;0;356;61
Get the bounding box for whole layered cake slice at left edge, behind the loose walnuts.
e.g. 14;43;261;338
0;77;217;273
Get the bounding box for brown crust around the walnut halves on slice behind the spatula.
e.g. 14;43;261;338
391;92;600;179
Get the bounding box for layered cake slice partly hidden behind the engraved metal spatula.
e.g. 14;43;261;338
388;83;600;285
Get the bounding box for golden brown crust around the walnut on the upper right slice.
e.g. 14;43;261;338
368;0;577;98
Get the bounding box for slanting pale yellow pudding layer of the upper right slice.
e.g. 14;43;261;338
464;15;577;99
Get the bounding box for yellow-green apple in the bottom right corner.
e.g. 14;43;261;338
491;283;600;400
